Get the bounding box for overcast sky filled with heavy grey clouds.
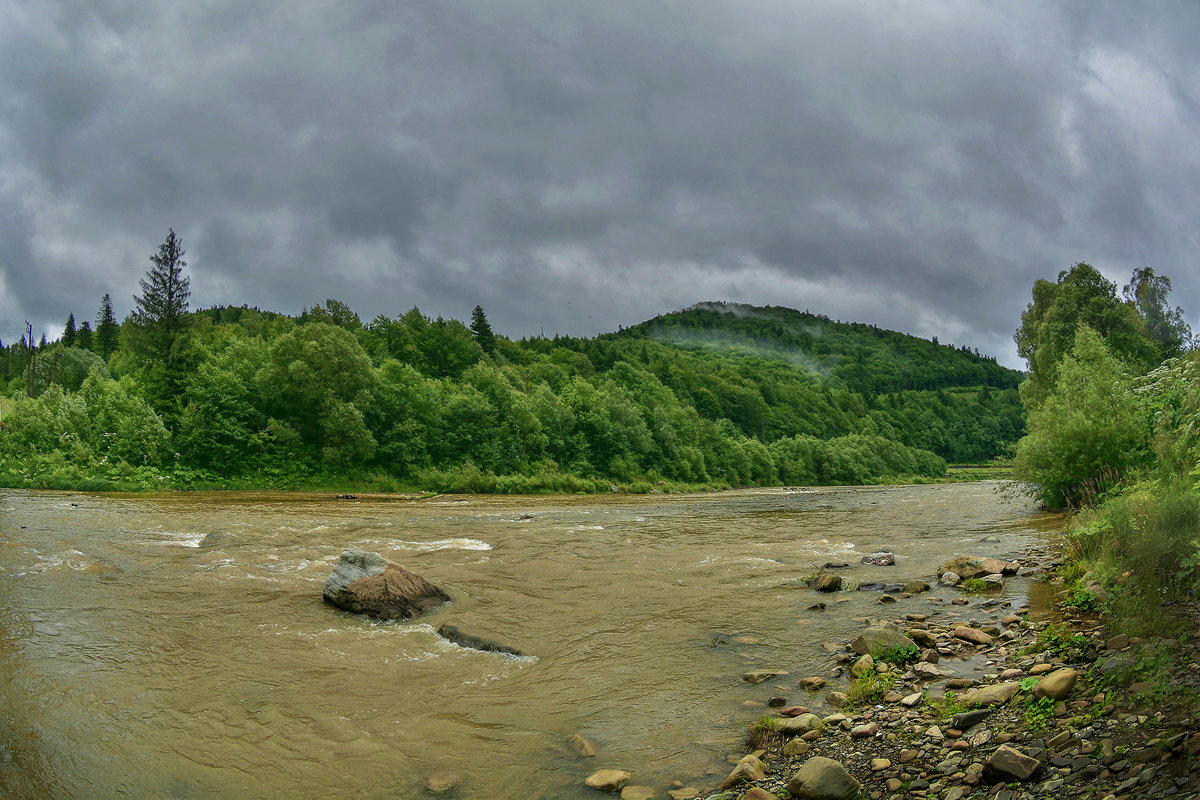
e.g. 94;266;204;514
0;0;1200;367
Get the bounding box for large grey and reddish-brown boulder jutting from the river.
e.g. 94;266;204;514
323;547;450;619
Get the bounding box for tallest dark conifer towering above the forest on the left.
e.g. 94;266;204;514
133;230;192;411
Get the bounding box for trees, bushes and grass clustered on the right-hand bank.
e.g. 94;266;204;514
1014;264;1200;636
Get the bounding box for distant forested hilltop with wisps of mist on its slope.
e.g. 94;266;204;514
618;302;1022;395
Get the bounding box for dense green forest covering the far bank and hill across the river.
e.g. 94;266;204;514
0;233;1024;492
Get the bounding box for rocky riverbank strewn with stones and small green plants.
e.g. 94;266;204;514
691;549;1200;800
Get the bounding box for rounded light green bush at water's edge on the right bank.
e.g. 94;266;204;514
1013;326;1151;509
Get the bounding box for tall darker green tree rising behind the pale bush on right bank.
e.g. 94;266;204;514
1013;263;1158;409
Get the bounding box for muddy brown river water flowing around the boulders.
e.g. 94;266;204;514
0;483;1058;799
